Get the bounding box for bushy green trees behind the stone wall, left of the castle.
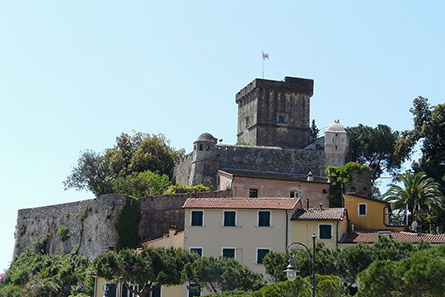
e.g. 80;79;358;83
64;132;184;196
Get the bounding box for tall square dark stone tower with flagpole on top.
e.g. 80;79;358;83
236;77;314;149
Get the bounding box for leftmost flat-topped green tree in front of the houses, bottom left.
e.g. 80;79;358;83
92;248;197;297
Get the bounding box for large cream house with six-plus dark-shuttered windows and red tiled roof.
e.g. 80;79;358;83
180;198;299;276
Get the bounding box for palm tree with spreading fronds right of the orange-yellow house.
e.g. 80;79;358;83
383;172;443;220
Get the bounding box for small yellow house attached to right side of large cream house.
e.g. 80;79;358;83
291;207;348;249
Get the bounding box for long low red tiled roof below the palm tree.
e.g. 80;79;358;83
342;230;445;243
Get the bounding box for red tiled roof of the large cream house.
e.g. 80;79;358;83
182;198;299;209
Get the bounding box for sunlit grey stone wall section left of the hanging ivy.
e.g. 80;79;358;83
14;195;125;258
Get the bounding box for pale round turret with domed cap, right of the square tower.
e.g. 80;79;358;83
324;120;349;166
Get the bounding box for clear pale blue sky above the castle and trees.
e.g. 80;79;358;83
0;0;445;271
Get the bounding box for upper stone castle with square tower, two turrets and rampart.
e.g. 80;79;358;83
173;77;349;189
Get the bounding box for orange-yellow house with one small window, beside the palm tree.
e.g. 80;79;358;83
343;194;405;231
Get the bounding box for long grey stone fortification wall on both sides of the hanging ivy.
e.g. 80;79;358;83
14;191;232;258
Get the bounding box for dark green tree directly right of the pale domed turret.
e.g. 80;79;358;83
346;124;411;181
